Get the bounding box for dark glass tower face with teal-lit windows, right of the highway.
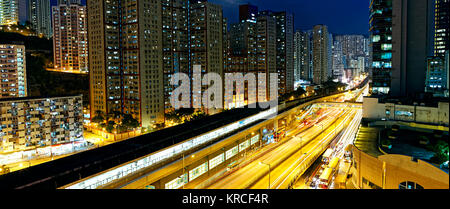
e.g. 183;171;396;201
369;0;392;94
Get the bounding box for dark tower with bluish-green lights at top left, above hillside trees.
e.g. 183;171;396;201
28;0;53;38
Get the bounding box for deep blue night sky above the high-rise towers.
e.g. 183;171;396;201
51;0;370;35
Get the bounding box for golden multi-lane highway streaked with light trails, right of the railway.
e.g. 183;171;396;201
192;83;367;189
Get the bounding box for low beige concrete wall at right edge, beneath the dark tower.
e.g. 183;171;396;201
363;97;449;126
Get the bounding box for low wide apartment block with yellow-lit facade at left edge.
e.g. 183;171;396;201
0;95;83;153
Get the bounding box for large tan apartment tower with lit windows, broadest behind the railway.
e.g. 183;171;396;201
87;0;165;127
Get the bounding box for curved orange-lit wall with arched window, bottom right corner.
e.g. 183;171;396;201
351;145;449;189
